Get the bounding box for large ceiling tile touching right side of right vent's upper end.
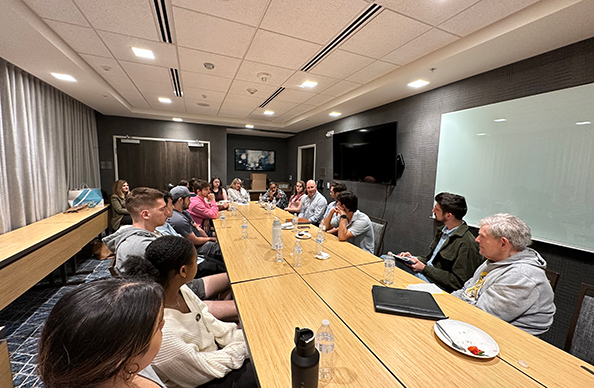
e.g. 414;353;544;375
340;10;431;59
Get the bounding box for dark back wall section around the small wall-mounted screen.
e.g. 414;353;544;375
227;135;289;188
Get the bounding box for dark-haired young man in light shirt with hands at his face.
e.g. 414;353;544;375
324;191;374;254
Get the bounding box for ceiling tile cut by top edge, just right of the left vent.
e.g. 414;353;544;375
172;0;270;27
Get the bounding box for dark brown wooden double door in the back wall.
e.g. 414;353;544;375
116;139;210;190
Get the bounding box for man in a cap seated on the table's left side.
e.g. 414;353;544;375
167;186;225;273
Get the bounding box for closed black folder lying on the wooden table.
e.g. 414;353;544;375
371;286;447;321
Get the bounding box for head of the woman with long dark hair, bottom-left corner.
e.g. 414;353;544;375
37;278;165;388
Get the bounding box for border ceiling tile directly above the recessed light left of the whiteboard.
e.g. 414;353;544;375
382;28;458;66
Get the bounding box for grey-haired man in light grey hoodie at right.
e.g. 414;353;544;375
452;214;555;335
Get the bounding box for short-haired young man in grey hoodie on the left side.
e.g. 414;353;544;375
103;187;237;320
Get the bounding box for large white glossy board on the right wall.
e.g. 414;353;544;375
435;84;594;252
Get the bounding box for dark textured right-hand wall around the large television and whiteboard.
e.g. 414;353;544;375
288;39;594;347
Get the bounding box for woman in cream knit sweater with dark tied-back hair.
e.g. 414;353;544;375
126;236;257;388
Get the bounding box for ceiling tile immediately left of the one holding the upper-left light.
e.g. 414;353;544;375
45;20;112;58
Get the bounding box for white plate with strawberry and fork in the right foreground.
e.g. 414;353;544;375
433;319;499;358
